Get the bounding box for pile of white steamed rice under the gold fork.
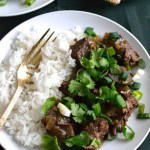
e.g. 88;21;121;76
0;26;83;149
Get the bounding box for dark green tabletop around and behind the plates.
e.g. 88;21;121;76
0;0;150;150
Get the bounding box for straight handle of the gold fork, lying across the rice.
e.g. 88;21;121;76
0;86;24;129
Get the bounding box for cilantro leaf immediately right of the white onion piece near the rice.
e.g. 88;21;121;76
71;103;86;123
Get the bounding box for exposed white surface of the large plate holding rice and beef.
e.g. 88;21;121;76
0;11;150;150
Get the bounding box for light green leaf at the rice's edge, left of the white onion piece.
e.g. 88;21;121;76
42;97;57;115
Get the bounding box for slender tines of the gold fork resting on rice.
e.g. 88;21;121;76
22;28;57;68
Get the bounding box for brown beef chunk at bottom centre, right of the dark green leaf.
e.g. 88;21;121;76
85;118;109;142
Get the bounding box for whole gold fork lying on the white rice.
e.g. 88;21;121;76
0;29;56;129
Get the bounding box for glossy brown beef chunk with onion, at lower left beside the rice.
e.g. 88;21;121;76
42;106;75;143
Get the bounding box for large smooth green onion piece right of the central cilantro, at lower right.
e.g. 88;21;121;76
114;94;126;108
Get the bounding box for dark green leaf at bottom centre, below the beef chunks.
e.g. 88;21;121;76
64;131;90;148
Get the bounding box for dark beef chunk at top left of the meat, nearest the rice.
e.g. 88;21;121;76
70;37;96;61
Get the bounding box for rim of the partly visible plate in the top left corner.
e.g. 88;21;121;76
0;0;55;17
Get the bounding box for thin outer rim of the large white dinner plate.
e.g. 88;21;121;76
0;9;150;150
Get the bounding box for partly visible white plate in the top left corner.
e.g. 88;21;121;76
0;0;54;17
